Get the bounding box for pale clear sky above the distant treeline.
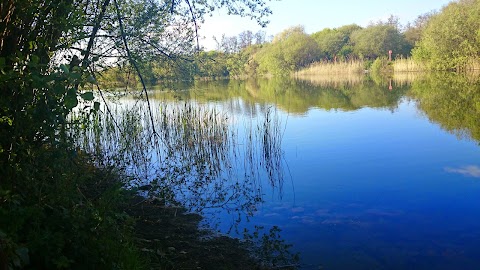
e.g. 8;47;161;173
199;0;453;49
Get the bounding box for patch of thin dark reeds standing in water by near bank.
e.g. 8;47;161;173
71;99;283;226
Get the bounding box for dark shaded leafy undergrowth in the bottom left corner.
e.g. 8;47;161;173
0;146;142;269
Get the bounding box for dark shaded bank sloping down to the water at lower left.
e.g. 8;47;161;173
0;147;294;270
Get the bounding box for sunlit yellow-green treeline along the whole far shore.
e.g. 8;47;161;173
102;0;480;85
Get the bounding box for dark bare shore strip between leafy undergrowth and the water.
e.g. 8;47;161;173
126;197;268;269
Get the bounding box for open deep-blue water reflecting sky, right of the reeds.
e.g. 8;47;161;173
214;101;480;269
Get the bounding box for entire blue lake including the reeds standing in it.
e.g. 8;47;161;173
84;74;480;269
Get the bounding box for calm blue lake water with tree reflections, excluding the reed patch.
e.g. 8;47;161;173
113;74;480;269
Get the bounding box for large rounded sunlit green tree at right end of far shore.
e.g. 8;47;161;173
413;0;480;70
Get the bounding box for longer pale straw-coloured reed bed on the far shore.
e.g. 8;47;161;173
295;60;365;76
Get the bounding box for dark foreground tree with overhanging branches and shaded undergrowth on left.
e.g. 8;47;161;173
0;0;304;269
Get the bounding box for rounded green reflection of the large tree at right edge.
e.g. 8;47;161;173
410;73;480;141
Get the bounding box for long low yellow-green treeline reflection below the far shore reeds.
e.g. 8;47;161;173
152;76;409;115
